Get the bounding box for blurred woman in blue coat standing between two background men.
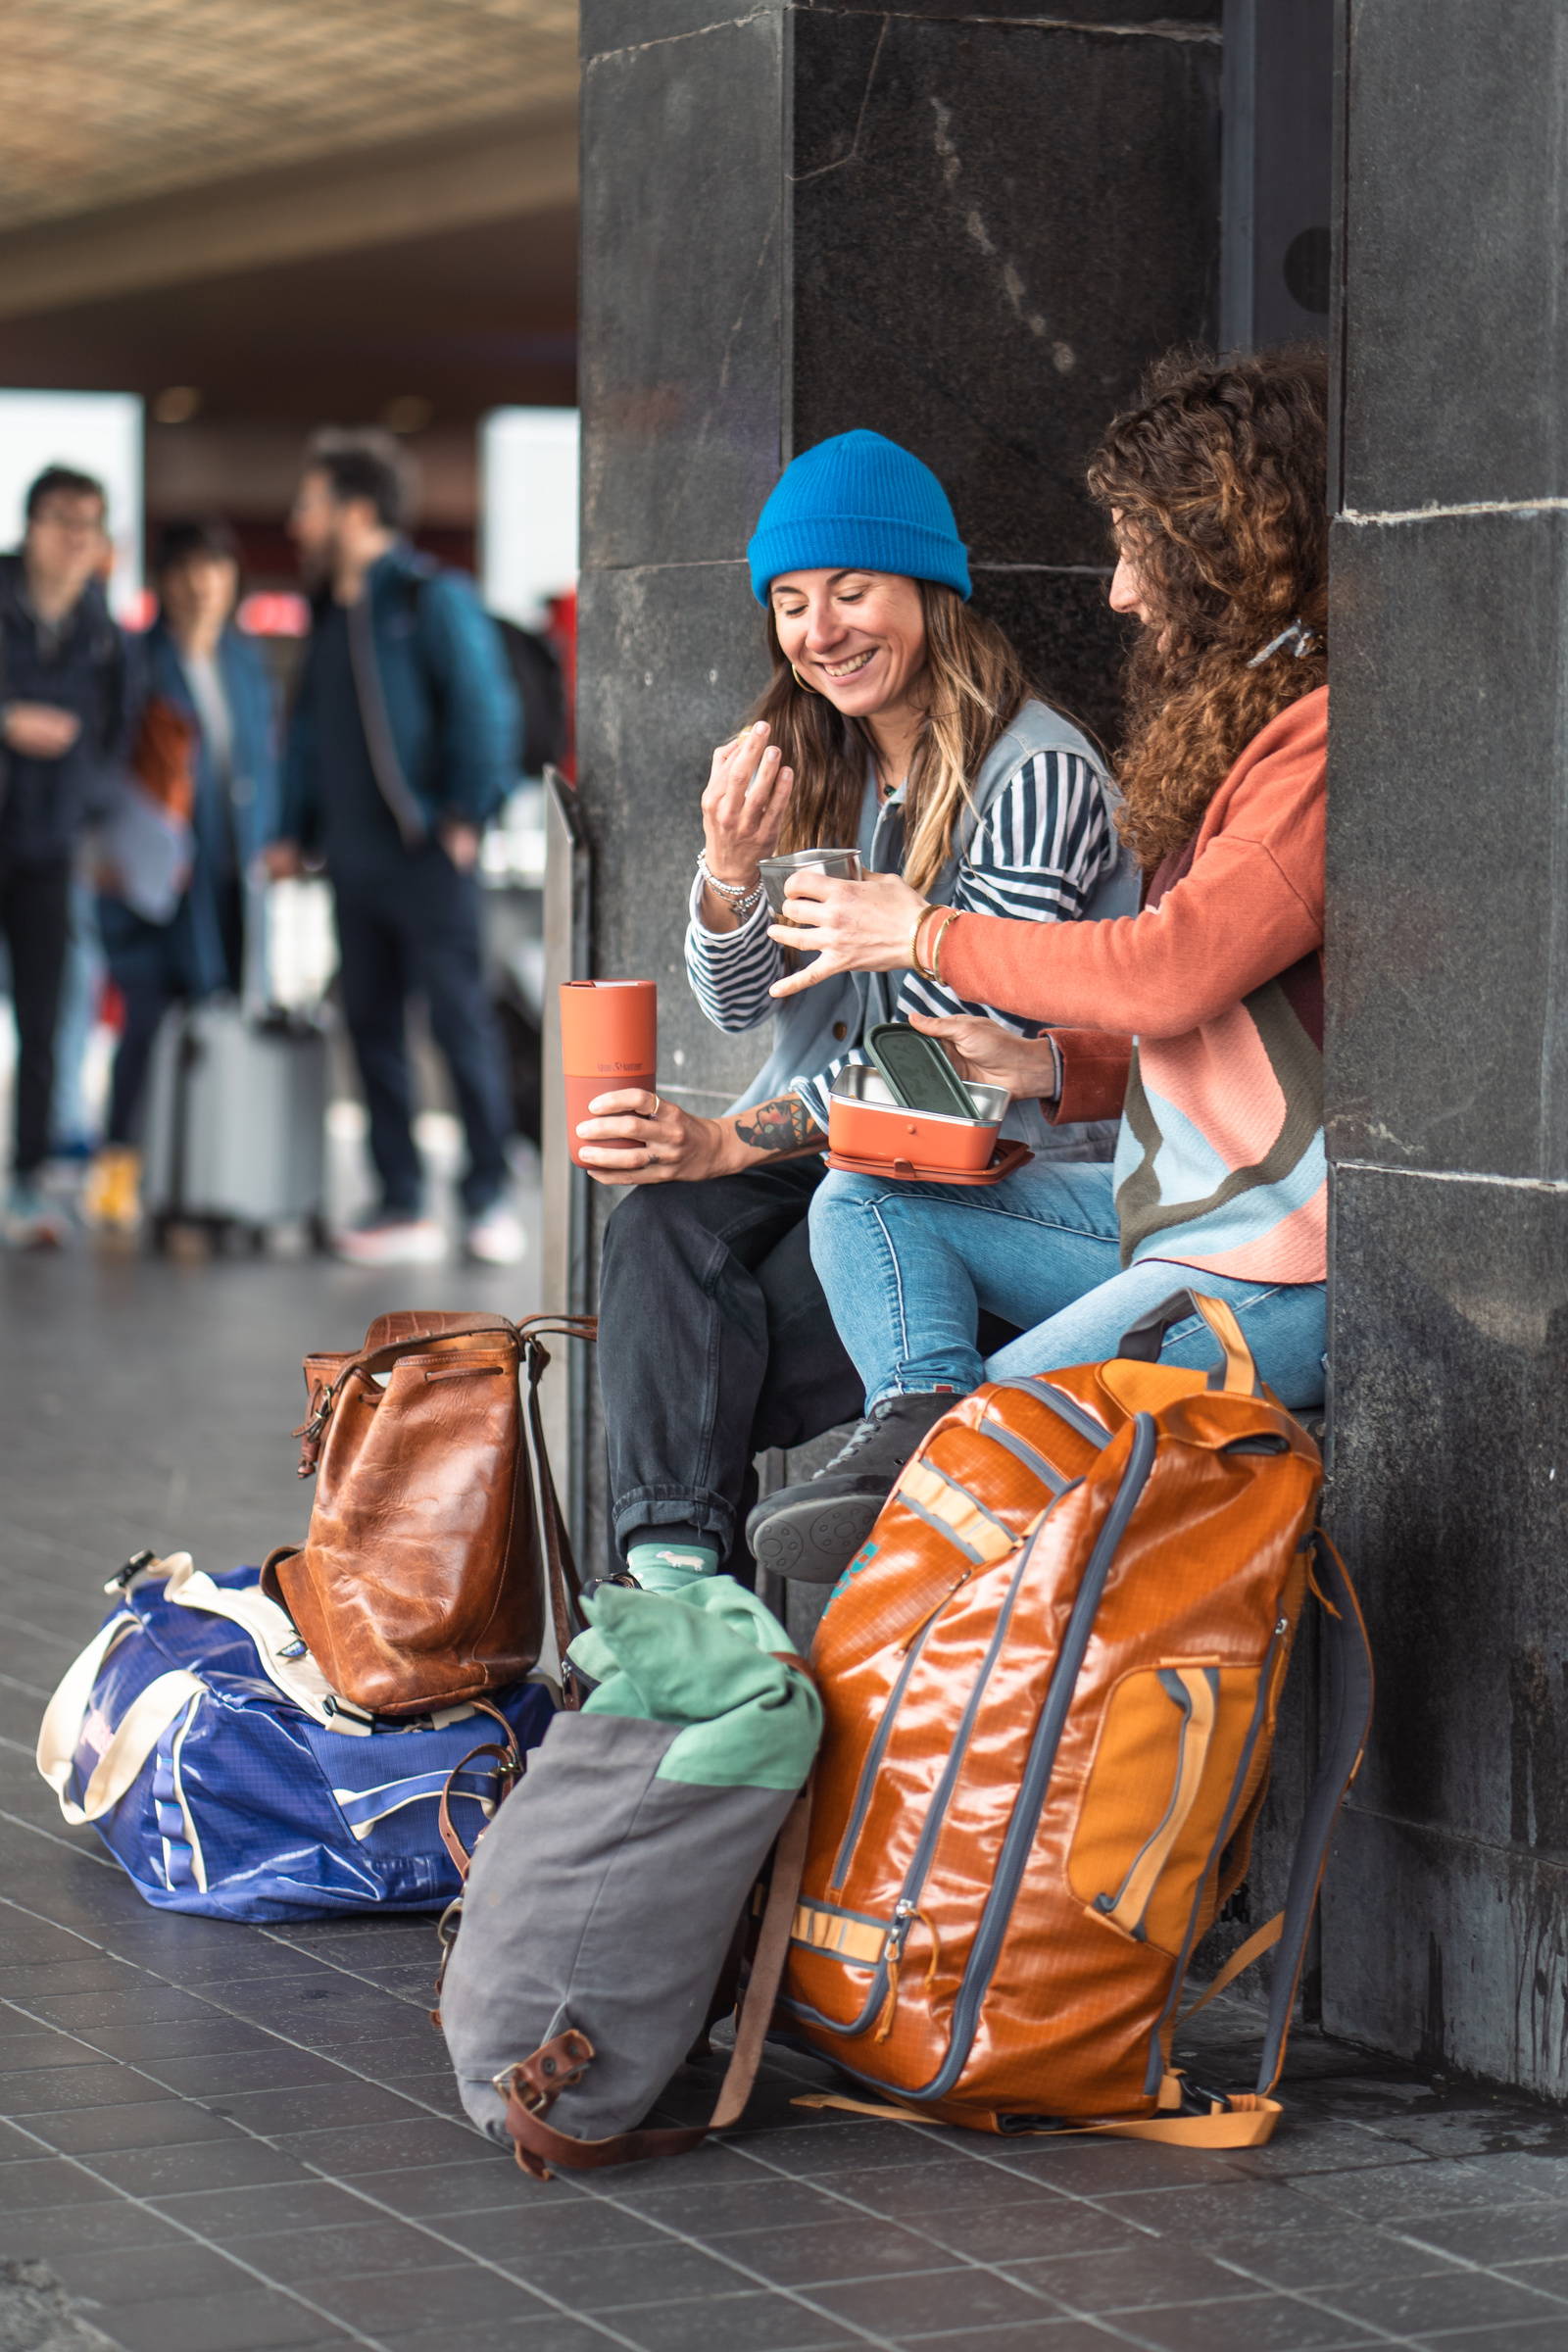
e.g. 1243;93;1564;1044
82;522;277;1233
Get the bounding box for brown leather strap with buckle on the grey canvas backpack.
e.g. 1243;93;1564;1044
501;1788;811;2180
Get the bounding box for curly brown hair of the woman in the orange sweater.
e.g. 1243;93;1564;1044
1089;346;1328;870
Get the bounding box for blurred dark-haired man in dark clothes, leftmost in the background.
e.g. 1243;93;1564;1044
0;466;134;1249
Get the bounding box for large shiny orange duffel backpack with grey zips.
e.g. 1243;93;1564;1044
780;1292;1371;2147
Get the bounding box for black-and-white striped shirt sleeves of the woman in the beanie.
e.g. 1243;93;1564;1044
686;753;1116;1131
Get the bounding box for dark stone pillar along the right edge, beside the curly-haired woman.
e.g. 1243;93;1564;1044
1324;0;1568;2095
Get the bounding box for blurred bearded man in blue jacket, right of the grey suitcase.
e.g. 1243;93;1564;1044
268;433;522;1265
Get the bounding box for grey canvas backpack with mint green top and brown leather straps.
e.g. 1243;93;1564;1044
440;1576;823;2180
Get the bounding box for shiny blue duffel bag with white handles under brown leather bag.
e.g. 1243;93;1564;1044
37;1552;555;1919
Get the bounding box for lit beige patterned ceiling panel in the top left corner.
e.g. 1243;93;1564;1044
0;0;578;230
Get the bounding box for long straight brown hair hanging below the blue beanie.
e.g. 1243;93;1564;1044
753;581;1034;889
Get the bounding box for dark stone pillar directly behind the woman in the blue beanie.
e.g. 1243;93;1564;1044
566;0;1220;1580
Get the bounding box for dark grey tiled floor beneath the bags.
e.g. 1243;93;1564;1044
0;1253;1568;2352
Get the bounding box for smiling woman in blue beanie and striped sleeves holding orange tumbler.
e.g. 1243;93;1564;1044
578;433;1136;1590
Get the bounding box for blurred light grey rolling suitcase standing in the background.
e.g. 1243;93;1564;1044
143;998;326;1247
